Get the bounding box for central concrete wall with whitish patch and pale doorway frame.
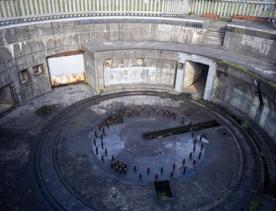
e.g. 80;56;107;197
85;46;220;103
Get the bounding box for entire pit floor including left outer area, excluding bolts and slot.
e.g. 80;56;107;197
0;85;270;210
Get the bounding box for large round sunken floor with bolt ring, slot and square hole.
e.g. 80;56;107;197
36;92;258;210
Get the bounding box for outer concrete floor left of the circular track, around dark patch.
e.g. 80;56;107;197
0;85;93;210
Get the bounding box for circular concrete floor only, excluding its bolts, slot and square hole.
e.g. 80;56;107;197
36;93;256;210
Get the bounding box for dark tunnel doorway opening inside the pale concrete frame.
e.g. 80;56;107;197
183;61;209;99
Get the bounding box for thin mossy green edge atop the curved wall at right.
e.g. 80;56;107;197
218;60;276;90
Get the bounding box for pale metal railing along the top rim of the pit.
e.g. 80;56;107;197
0;0;276;20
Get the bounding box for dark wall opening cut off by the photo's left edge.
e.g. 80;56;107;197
0;85;14;114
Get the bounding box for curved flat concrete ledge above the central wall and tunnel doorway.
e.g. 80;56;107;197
83;41;276;82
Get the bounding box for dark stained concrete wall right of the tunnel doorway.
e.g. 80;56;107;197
211;63;276;142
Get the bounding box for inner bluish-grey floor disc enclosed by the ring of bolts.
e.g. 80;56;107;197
92;110;205;184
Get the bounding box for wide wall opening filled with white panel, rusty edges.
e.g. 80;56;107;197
47;52;85;87
